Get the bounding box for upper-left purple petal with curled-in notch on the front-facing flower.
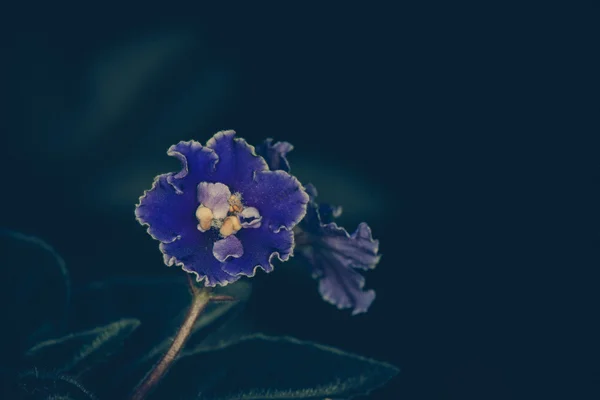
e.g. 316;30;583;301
167;140;218;194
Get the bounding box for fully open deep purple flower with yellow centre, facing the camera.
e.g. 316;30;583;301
135;131;309;286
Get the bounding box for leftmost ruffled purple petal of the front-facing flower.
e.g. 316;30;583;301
135;174;196;242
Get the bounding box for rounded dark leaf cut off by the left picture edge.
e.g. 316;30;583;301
0;229;70;365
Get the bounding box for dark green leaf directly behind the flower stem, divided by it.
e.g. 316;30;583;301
73;274;252;397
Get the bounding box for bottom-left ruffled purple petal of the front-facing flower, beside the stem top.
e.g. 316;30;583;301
160;224;240;286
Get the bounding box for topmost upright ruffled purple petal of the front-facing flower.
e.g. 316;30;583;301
206;131;268;193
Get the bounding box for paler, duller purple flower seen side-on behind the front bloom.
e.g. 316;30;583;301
257;139;381;315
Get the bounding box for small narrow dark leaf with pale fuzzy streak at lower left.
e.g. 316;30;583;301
25;319;140;374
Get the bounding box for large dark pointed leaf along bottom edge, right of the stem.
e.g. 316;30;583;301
151;334;399;400
